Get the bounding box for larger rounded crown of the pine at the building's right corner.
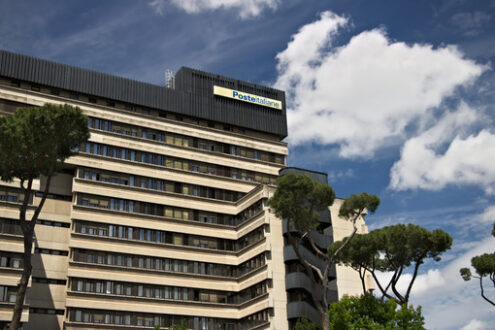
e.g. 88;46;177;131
268;173;335;233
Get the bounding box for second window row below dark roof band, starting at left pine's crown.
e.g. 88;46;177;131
88;117;284;164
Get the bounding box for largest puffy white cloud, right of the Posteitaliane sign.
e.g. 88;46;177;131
275;11;486;158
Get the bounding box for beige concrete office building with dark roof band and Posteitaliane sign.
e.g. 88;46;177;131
0;51;365;330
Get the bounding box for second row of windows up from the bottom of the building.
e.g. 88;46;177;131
71;278;267;305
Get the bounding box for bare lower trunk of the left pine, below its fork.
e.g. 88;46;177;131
10;228;33;330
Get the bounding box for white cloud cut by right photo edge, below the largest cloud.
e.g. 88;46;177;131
390;103;495;193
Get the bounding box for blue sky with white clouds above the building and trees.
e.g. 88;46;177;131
0;0;495;330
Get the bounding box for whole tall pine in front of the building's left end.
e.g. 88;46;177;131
0;104;89;329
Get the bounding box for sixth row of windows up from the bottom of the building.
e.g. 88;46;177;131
79;168;246;202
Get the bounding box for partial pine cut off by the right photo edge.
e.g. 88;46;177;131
459;223;495;306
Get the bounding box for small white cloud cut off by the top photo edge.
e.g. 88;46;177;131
150;0;279;19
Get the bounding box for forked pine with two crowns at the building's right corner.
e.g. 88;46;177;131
268;173;380;330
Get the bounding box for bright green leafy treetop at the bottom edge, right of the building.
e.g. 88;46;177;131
328;294;424;330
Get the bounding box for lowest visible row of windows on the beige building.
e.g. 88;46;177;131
68;308;270;330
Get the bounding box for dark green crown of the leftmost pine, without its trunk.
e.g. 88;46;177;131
0;104;89;181
